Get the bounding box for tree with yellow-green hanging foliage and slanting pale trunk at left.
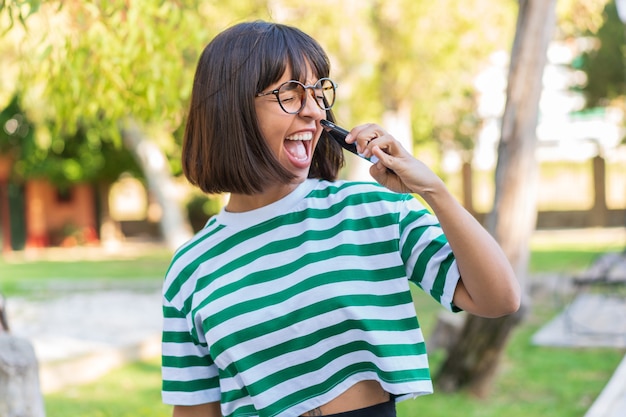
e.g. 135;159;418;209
0;0;234;248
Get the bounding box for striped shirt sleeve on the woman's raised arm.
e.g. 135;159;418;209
399;196;461;312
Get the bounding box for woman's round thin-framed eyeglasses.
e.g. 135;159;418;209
256;78;337;114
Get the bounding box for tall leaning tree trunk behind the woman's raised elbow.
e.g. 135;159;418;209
436;0;556;397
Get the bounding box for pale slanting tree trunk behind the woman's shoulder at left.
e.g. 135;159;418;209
122;121;193;250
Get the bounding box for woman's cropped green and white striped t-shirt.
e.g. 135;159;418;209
162;179;459;417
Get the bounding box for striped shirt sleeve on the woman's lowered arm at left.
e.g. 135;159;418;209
161;292;221;405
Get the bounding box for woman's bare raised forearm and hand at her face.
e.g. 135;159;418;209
346;124;520;317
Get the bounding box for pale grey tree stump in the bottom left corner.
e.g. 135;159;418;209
0;333;45;417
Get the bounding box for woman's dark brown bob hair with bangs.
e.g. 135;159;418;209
182;21;344;194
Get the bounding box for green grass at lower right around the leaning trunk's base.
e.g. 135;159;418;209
398;290;626;417
